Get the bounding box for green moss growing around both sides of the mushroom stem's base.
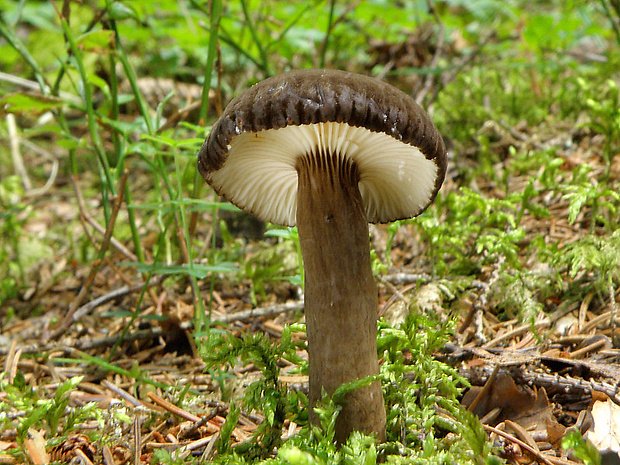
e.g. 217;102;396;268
205;312;496;465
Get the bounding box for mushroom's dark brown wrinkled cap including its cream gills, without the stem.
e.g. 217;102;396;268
198;70;446;226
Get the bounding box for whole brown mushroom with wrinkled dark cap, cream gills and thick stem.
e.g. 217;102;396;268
198;69;446;443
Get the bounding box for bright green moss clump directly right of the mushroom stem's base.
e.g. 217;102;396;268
378;312;492;463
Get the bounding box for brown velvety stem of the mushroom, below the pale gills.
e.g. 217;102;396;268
296;153;385;444
